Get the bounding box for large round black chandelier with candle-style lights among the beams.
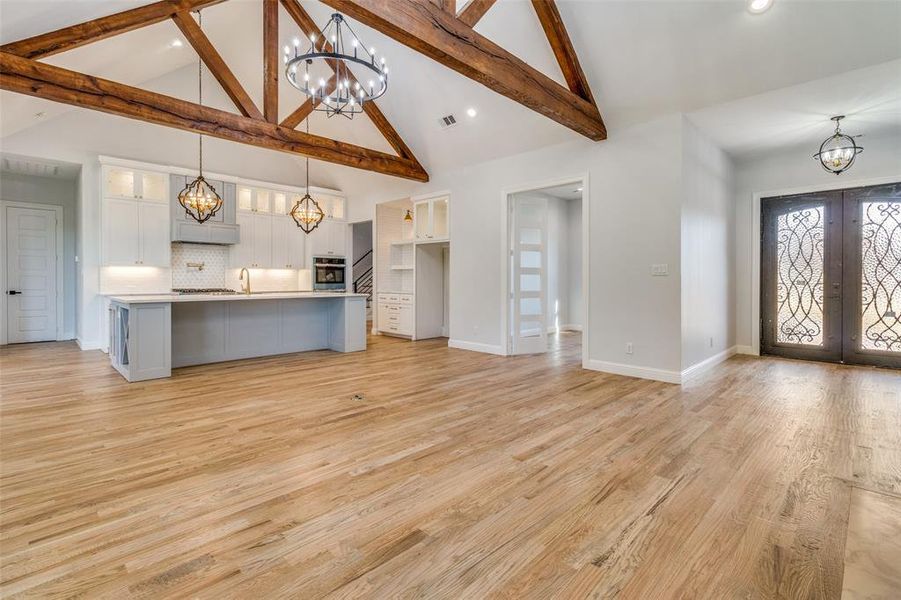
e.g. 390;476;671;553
284;13;388;119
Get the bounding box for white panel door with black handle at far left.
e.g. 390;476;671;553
6;207;59;344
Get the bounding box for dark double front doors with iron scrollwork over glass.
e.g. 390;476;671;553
761;184;901;368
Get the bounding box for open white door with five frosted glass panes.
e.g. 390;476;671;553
510;198;547;354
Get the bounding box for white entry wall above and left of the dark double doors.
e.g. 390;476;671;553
735;129;901;352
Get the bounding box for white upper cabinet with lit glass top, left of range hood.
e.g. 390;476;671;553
100;166;170;267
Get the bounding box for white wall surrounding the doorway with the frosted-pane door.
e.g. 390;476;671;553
372;115;683;379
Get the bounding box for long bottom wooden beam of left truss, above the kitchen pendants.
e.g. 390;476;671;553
0;52;429;181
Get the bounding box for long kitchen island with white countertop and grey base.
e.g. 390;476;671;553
109;292;366;381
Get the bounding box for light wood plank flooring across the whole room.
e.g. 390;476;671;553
0;334;901;600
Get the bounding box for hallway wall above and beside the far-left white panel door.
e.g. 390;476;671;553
0;173;77;339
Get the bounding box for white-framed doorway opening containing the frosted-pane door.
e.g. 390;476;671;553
504;178;588;364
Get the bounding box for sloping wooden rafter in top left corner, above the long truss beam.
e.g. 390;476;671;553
0;0;224;59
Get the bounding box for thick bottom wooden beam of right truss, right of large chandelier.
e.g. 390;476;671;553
323;0;607;141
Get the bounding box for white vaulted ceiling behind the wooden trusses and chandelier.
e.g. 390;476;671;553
0;0;901;176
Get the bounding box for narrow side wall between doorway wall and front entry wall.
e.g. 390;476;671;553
682;120;735;370
